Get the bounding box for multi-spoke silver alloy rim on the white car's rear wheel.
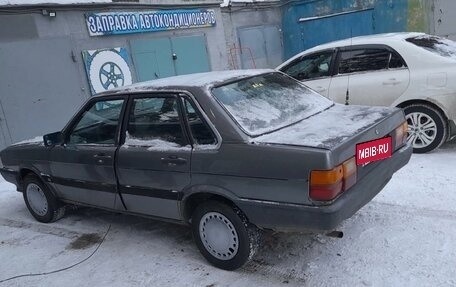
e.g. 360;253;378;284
406;112;437;148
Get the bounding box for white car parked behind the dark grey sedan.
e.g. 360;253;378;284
277;33;456;153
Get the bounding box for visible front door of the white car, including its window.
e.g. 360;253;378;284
280;50;334;97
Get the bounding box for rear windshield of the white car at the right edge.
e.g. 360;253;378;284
406;35;456;60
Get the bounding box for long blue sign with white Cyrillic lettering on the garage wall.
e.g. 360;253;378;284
85;9;216;36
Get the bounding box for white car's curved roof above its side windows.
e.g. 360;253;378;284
276;32;426;69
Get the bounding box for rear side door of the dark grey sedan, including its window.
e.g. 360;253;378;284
117;94;192;219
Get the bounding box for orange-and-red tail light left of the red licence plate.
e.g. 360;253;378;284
310;157;357;201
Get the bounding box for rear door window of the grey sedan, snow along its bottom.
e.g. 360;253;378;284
127;97;185;147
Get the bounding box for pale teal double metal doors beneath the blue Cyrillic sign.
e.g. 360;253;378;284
130;35;210;81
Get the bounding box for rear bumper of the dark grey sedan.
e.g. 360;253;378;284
237;145;413;230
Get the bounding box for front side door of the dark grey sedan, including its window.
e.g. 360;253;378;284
50;97;125;208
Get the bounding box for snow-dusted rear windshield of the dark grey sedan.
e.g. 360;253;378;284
212;73;333;136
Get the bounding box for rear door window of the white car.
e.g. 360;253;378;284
339;49;390;74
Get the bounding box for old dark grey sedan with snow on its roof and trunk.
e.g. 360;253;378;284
0;70;412;270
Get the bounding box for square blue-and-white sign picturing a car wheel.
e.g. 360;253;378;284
82;48;132;95
